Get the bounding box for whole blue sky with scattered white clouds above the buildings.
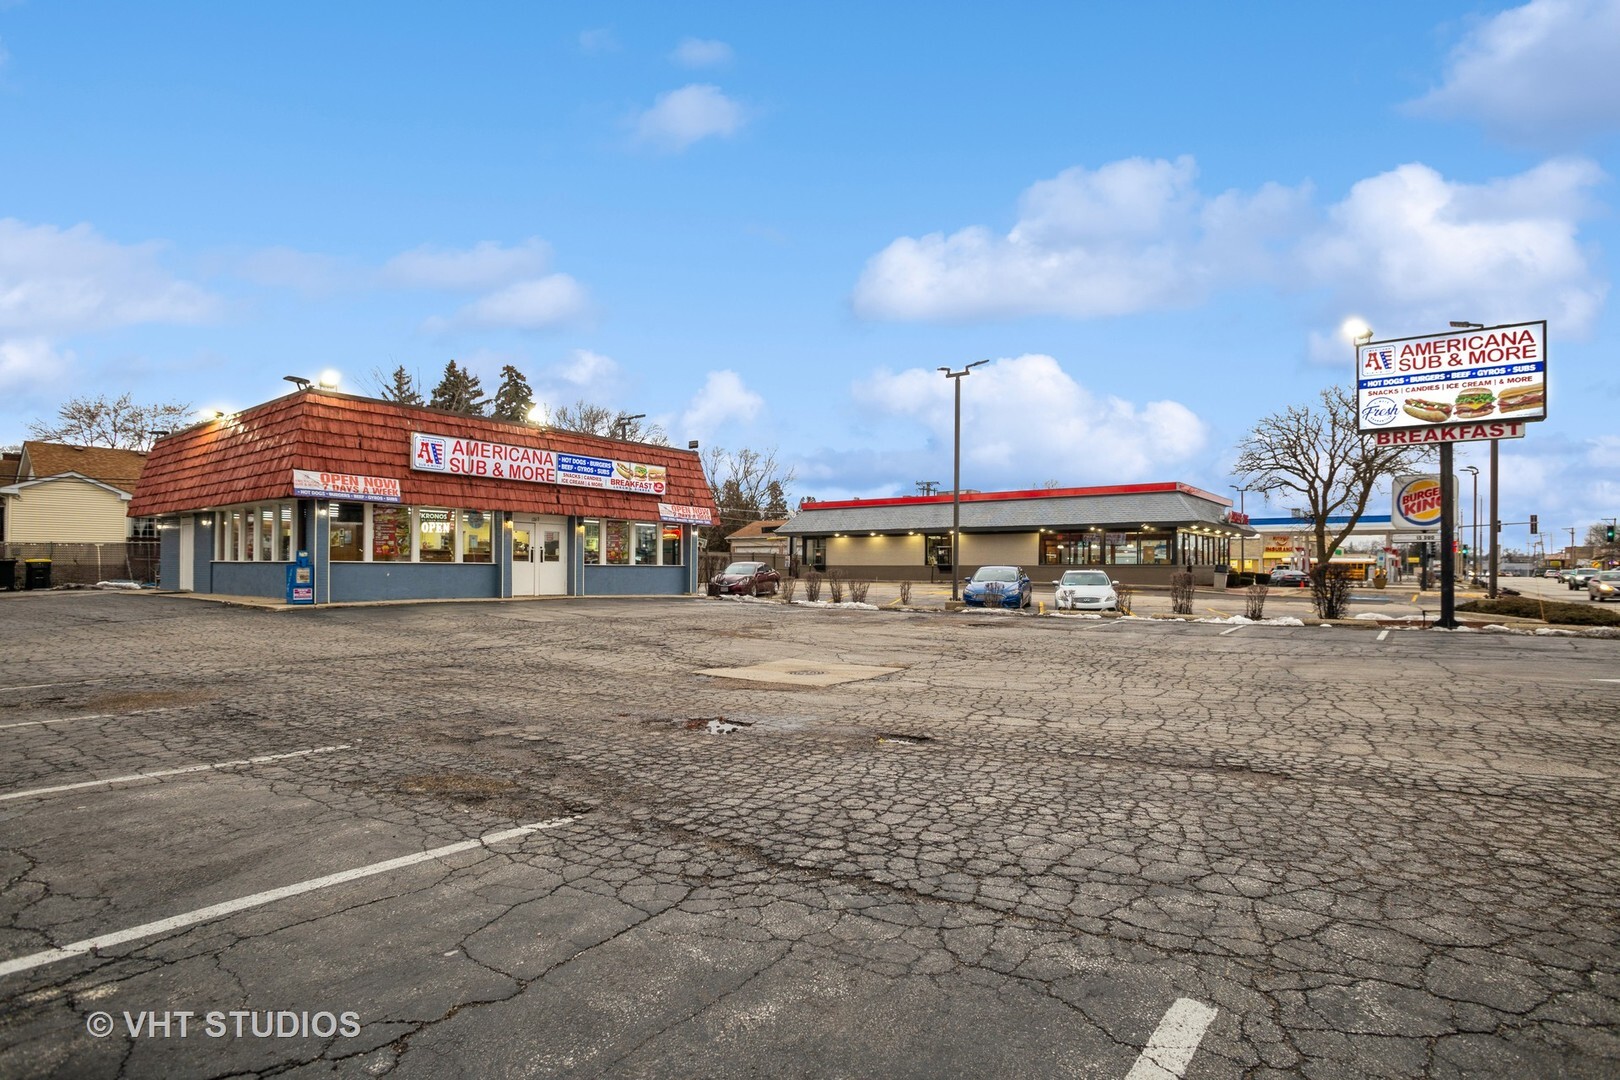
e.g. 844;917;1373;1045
0;0;1620;546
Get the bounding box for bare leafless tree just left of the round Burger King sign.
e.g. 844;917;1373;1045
1233;385;1427;608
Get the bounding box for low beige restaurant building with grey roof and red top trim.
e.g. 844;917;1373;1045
776;483;1257;585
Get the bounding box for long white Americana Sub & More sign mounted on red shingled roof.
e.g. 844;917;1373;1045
410;431;669;495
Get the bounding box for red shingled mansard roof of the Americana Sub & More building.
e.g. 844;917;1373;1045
130;389;714;521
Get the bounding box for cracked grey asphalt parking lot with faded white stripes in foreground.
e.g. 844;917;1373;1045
0;593;1620;1080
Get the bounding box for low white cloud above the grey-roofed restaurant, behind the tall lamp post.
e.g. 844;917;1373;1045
854;355;1210;489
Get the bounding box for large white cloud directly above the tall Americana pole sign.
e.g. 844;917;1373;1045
1298;160;1607;363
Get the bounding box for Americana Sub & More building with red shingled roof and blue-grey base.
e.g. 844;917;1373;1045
128;389;714;604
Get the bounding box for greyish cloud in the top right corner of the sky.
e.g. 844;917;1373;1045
1411;0;1620;146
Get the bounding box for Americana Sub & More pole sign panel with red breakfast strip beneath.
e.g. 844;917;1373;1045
1356;321;1547;444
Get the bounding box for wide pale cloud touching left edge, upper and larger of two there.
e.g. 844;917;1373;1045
0;219;220;334
